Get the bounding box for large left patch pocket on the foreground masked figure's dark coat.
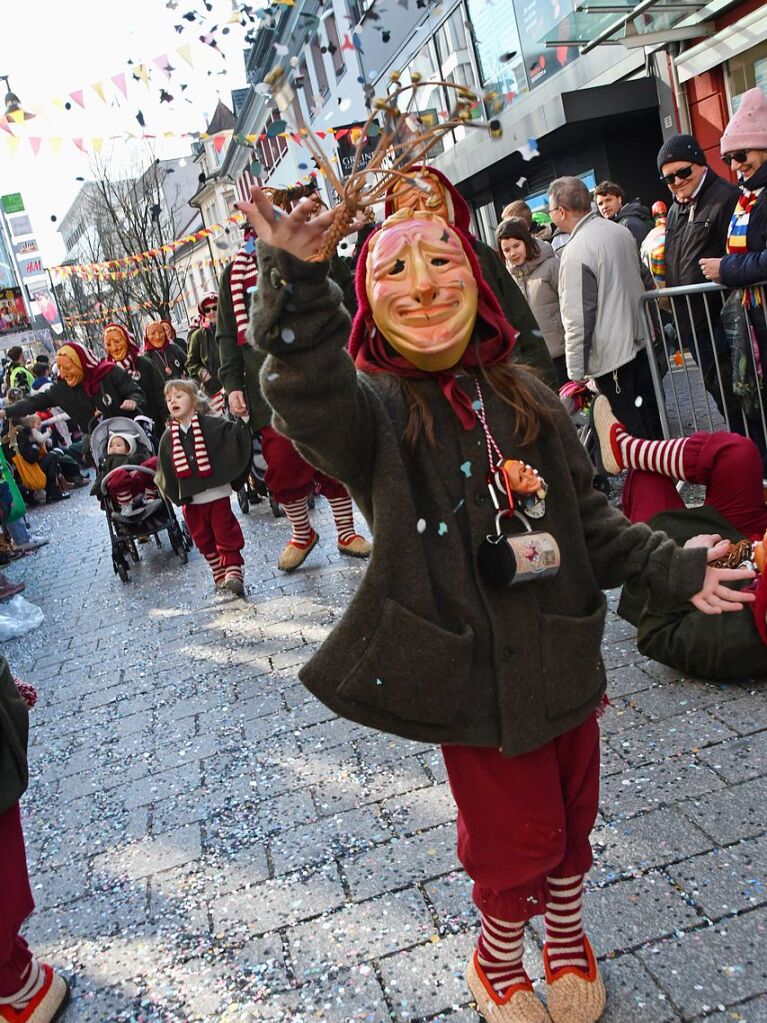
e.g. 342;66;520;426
337;598;473;724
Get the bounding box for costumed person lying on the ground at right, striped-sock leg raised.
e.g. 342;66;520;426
593;395;767;681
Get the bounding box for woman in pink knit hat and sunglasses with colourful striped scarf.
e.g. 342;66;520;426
701;89;767;442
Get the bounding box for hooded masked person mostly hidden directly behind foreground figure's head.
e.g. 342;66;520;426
386;165;557;391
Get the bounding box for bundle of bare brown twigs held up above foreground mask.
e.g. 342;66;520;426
266;68;502;261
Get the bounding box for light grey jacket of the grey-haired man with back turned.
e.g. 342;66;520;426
559;213;647;381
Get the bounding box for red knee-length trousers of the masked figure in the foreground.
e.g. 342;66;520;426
442;713;599;921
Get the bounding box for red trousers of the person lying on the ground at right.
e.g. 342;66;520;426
623;431;767;536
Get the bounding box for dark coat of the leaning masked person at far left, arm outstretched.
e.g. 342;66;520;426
5;366;144;433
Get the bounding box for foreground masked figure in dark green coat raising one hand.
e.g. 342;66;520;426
239;189;751;1023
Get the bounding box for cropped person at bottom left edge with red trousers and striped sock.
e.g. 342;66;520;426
0;657;70;1023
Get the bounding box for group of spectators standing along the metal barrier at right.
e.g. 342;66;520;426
496;89;767;466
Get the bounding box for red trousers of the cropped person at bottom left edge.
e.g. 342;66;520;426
0;803;35;998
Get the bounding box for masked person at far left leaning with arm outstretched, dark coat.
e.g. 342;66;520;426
0;341;144;457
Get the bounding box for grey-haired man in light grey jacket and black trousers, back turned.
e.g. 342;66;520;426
549;178;663;438
